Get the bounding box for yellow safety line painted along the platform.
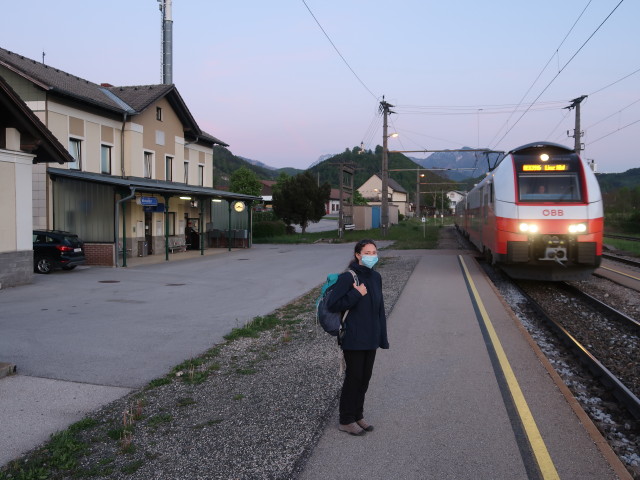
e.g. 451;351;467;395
458;255;560;480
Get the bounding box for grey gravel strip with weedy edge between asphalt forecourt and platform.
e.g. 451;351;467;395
0;251;418;480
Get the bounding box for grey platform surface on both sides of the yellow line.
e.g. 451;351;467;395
301;251;617;480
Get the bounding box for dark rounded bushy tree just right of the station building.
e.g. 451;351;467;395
273;171;331;234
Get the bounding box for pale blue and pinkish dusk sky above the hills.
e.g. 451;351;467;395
0;0;640;172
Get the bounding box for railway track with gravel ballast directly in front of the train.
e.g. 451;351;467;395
517;282;640;420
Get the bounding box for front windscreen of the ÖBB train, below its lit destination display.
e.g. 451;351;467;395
518;172;582;202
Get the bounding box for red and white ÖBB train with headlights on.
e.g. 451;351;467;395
456;142;604;280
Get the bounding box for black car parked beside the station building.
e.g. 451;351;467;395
33;230;85;273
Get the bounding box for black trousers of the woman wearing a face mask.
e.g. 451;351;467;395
340;350;376;425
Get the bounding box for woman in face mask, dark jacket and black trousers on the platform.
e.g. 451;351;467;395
327;239;389;435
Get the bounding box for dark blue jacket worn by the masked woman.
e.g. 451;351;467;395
327;261;389;350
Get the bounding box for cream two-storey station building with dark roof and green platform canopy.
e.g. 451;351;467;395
0;48;259;265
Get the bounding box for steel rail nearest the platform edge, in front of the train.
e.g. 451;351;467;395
515;284;640;420
